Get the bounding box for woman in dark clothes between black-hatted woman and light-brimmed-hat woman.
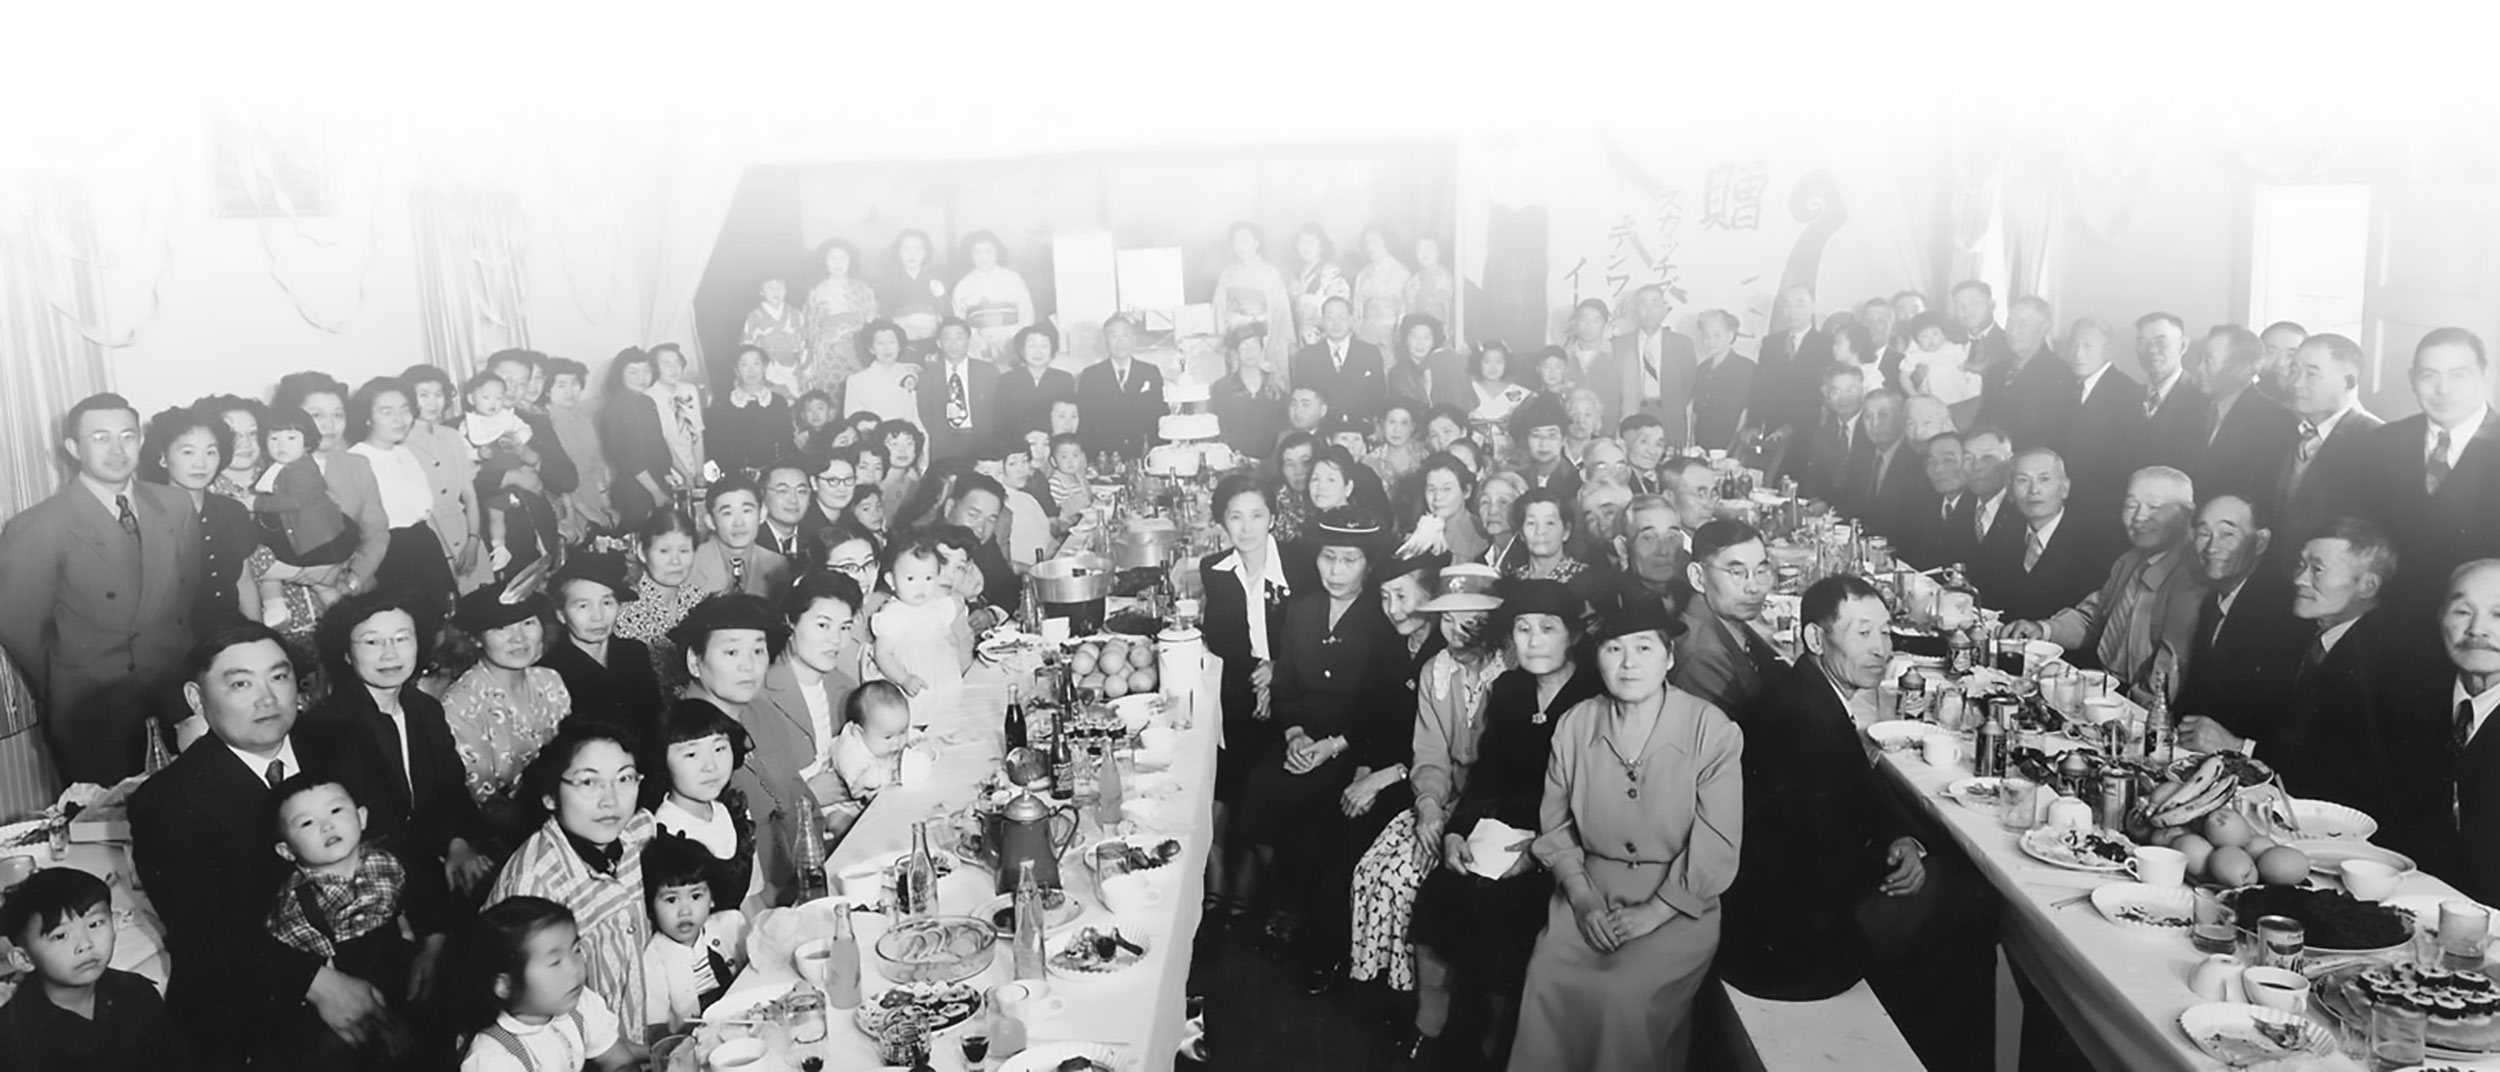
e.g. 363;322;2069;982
1308;555;1448;990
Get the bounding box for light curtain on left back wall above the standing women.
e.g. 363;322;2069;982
413;185;530;382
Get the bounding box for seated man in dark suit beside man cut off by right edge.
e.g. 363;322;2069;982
2258;517;2438;852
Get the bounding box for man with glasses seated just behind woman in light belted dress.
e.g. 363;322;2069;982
1668;520;1788;725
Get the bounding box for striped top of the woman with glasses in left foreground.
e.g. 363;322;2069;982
485;812;660;1035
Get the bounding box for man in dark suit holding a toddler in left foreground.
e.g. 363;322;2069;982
130;622;395;1070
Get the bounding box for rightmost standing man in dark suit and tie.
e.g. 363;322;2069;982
2338;327;2500;612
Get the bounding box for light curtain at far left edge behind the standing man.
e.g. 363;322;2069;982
0;175;113;817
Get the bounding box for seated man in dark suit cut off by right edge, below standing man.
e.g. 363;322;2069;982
2433;557;2500;905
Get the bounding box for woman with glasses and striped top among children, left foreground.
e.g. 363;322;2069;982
485;720;660;1037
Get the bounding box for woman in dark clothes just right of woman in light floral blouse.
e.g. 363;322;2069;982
538;552;660;737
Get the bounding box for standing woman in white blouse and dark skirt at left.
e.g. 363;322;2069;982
348;375;455;637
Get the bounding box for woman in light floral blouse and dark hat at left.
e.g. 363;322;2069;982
443;570;573;845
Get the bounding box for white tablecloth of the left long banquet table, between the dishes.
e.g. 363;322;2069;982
708;655;1223;1072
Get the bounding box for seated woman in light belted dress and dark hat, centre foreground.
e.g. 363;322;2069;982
1510;600;1745;1072
